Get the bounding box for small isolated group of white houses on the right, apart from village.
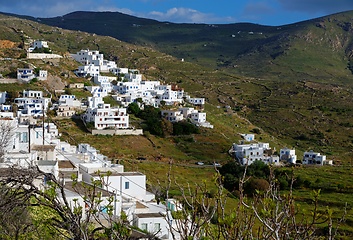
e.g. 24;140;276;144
230;134;332;166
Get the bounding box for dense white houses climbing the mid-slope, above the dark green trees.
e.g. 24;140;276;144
72;50;213;129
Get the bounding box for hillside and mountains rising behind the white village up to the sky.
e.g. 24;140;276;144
1;12;353;161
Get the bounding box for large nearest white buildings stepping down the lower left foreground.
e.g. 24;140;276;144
0;104;176;239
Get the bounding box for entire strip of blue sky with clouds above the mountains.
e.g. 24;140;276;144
0;0;353;26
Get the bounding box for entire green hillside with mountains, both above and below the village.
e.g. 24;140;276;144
0;12;353;236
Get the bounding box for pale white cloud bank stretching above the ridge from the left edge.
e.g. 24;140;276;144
1;0;236;23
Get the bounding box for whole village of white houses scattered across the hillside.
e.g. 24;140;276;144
0;38;332;239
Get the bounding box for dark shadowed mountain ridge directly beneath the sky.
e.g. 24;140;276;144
17;11;352;81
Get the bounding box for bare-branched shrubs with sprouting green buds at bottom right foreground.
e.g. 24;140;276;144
162;162;345;240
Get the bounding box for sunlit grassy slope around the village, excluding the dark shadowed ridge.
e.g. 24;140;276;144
0;11;353;236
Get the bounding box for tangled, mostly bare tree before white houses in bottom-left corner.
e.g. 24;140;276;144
0;167;131;240
